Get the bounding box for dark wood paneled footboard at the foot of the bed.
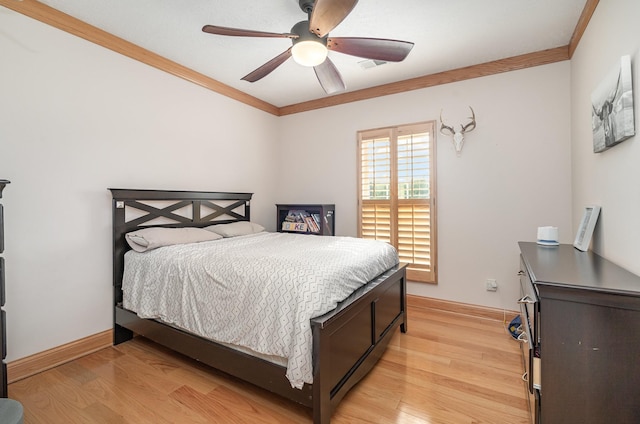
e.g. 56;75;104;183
311;265;407;424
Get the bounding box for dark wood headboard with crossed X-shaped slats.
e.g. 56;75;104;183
109;188;253;305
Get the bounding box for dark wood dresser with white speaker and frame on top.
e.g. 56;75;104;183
519;242;640;424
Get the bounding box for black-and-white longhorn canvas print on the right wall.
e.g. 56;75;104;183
591;55;635;153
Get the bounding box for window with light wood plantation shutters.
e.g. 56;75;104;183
358;121;436;283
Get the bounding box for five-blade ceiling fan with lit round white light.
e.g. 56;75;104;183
202;0;413;94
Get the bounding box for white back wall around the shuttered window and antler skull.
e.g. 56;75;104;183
277;62;573;310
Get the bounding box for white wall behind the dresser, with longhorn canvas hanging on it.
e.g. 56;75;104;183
571;0;640;274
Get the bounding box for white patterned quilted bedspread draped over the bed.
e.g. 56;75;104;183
123;232;398;388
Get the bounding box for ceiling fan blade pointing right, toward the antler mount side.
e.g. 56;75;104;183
327;37;413;62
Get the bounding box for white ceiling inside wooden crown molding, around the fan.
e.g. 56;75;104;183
35;0;586;107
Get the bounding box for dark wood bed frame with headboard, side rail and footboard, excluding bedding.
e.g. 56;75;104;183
110;189;407;424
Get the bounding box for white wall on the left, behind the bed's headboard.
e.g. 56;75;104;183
0;7;278;361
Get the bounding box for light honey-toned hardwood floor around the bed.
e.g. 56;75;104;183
9;307;529;424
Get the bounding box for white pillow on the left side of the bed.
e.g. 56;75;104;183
124;227;222;252
